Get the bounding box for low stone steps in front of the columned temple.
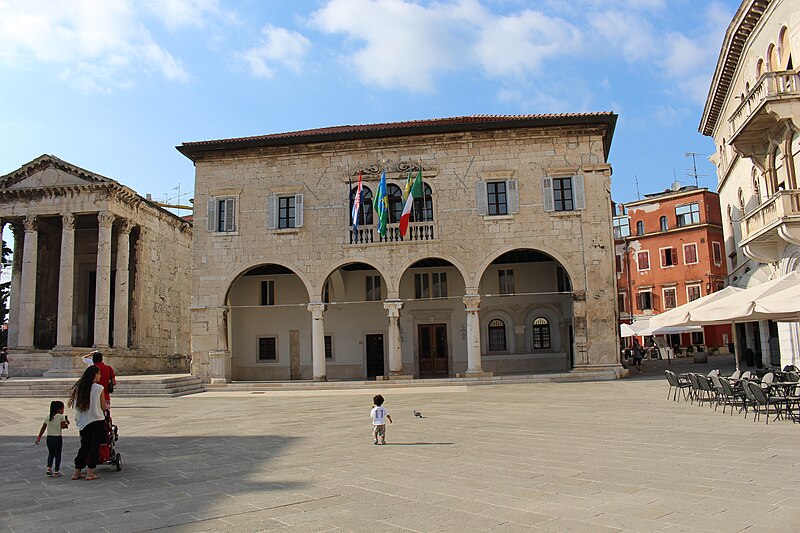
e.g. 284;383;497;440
0;374;203;398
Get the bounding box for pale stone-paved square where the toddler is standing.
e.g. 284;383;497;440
0;367;800;533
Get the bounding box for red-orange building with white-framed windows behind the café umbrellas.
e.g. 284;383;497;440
614;183;732;351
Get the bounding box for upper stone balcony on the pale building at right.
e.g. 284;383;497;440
728;69;800;157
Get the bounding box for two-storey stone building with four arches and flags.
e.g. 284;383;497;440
178;113;622;382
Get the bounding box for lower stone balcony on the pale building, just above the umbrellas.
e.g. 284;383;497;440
740;189;800;263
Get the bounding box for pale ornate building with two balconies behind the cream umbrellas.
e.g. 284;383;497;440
700;0;800;366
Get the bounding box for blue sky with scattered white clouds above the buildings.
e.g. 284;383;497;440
0;0;739;208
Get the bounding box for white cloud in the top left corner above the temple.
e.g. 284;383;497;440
0;0;189;92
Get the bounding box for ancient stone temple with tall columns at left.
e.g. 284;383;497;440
0;155;192;376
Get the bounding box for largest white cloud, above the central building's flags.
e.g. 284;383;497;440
311;0;580;91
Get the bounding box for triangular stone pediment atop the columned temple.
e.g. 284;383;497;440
0;154;117;190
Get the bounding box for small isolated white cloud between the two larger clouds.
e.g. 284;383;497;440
240;26;311;78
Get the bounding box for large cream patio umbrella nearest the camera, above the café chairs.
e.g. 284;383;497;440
689;272;800;324
